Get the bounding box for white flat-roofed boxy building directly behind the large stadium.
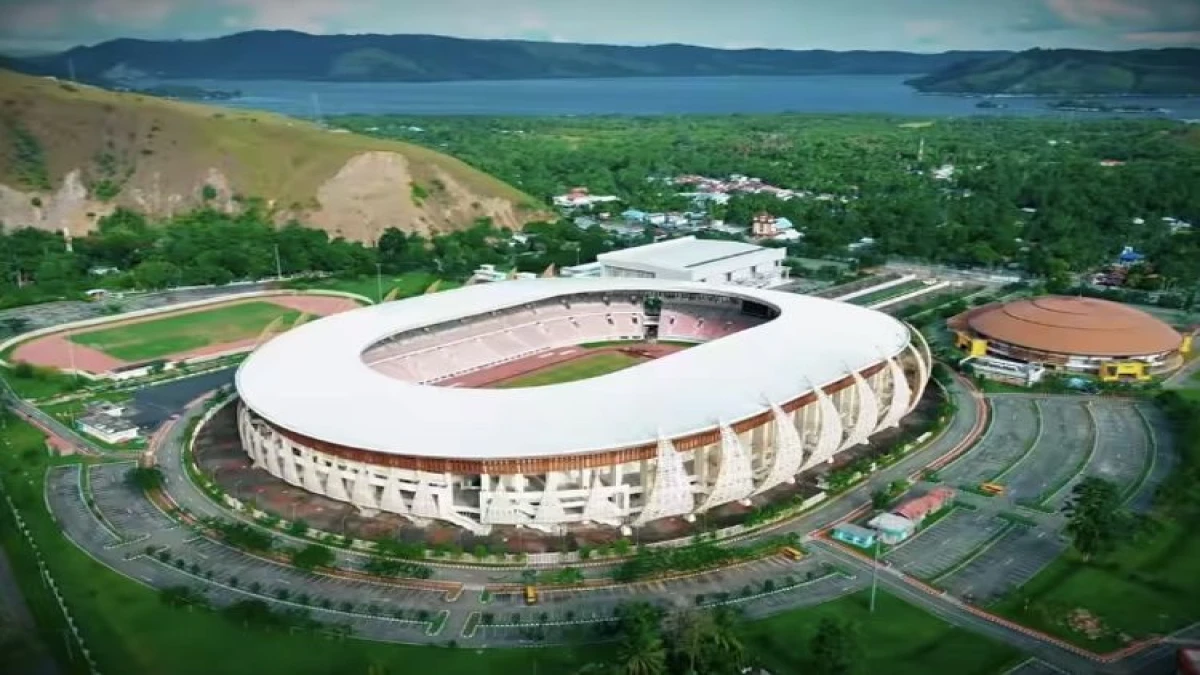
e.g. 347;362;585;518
596;237;788;288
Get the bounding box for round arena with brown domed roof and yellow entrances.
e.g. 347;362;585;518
949;295;1192;381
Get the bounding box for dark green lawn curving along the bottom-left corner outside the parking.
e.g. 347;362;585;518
0;417;593;675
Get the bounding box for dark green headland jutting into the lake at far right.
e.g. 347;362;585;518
908;49;1200;95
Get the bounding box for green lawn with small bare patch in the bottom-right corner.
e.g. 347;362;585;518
995;522;1200;651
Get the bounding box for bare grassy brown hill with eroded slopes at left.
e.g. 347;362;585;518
0;71;533;241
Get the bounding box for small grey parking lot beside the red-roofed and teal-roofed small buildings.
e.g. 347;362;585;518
886;508;1007;579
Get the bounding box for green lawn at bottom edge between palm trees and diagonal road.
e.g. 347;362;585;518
749;591;1025;675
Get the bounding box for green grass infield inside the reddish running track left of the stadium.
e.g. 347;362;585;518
71;301;300;362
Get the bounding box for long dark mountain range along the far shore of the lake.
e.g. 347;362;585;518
9;31;1003;82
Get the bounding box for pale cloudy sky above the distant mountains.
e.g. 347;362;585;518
0;0;1200;53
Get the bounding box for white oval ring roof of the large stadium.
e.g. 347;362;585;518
236;279;910;460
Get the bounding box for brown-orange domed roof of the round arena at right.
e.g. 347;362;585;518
967;295;1183;357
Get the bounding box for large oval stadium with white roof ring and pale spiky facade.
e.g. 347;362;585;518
236;279;931;534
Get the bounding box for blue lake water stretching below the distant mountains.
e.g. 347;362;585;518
159;76;1200;119
